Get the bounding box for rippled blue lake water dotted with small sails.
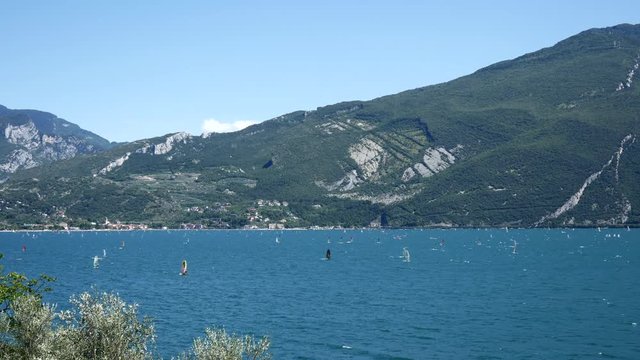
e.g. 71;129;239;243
0;229;640;359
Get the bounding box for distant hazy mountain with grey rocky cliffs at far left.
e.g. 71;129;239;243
0;106;111;179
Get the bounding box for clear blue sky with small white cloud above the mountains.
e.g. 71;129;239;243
0;0;640;141
